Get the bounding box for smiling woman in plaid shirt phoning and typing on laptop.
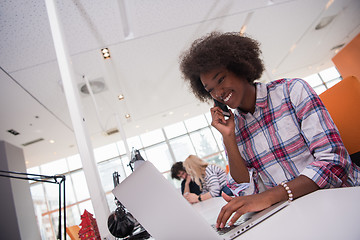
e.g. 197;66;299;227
180;33;360;228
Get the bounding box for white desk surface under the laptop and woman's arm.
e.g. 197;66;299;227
193;187;360;240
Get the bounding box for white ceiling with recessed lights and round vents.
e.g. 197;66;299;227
0;0;360;167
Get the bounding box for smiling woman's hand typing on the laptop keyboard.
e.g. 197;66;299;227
216;192;273;228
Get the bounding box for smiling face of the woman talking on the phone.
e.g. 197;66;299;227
200;68;256;112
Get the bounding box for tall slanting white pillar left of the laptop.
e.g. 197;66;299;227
45;0;114;239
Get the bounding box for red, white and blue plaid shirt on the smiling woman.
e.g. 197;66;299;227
228;79;360;195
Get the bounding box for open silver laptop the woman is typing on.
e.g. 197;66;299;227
112;161;288;240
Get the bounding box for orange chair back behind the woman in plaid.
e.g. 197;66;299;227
319;76;360;166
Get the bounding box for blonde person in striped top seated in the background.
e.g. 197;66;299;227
184;155;233;203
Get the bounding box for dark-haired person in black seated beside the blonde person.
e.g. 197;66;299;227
171;162;201;195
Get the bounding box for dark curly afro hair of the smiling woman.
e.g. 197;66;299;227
180;32;264;102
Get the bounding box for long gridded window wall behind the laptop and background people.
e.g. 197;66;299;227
28;111;226;239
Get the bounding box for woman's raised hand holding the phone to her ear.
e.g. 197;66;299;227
210;106;235;137
